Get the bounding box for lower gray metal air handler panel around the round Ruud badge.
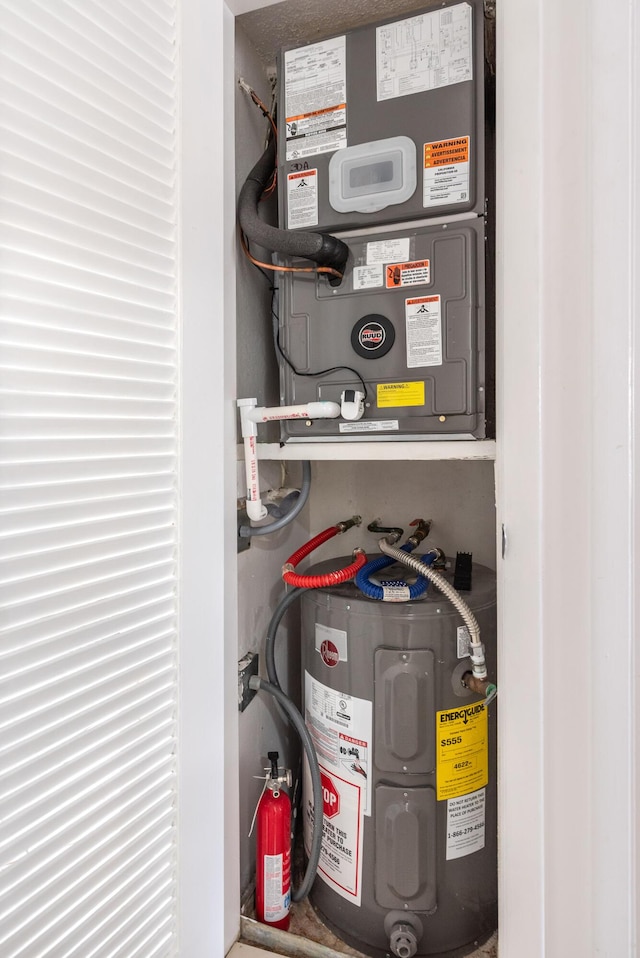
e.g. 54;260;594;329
278;217;485;441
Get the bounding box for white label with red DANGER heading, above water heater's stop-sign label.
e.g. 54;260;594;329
304;672;372;815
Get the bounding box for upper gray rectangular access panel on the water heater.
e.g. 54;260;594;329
374;649;435;774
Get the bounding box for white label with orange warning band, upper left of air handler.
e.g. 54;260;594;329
284;36;347;160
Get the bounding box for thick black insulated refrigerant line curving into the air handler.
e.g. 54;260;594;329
238;137;349;286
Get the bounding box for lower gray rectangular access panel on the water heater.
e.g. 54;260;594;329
375;785;437;913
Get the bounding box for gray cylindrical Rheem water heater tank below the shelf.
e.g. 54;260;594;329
302;558;497;958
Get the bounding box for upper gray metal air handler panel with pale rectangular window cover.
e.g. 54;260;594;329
278;0;485;231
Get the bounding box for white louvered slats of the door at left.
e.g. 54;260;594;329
0;0;178;958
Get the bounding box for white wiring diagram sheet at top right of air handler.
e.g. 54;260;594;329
376;3;473;100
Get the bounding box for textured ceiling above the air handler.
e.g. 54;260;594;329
237;0;438;66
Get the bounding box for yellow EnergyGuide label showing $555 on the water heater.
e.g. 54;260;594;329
436;702;489;801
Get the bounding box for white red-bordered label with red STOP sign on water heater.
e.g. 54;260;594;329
303;757;364;905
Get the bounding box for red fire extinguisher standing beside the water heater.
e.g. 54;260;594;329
256;752;291;931
